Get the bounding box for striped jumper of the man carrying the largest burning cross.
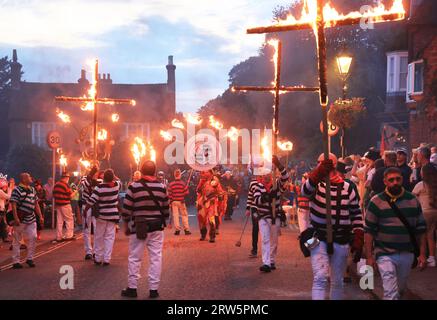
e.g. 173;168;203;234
302;179;363;244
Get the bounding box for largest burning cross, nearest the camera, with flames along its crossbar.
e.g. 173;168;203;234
240;0;405;254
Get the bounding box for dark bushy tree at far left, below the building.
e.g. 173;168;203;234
5;145;51;181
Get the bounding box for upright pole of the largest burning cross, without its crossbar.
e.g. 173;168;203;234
316;0;334;254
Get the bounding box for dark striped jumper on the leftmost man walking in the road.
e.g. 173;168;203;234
9;184;38;224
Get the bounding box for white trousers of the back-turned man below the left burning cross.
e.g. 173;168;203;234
94;218;116;263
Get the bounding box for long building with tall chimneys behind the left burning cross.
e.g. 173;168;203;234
0;50;176;159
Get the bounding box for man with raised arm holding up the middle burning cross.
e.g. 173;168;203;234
253;156;288;272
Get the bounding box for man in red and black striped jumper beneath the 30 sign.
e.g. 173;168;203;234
53;172;74;242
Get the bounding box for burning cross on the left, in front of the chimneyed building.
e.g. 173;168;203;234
55;59;136;163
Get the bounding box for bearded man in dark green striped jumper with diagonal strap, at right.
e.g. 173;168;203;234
365;167;426;300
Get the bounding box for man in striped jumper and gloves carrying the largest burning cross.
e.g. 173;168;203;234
302;153;364;300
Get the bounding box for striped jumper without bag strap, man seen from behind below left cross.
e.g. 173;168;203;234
88;181;121;223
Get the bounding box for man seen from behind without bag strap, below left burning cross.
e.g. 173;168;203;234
85;169;121;266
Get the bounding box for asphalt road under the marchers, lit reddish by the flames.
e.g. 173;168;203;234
0;205;369;300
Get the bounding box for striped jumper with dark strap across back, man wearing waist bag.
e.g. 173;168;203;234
122;179;169;226
